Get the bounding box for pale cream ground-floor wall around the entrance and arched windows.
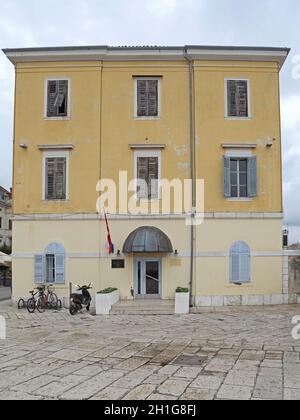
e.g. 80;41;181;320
13;220;282;299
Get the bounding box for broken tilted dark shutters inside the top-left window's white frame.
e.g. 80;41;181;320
46;80;69;118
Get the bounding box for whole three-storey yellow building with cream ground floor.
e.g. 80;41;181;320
4;46;289;306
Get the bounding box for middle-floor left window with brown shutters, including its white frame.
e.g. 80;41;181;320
42;151;70;201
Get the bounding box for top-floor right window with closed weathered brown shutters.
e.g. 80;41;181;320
225;79;250;118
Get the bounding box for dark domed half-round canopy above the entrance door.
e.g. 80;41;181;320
123;226;173;254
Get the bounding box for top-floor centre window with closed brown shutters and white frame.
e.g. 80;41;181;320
134;77;161;120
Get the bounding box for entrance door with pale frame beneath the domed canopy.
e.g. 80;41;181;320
134;258;161;299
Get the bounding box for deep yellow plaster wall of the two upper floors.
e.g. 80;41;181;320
14;61;282;214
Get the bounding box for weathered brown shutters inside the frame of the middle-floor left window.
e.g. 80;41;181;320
44;155;68;200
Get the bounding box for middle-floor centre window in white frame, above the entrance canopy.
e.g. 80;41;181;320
134;150;161;201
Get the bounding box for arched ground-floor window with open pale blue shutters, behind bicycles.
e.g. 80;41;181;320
35;243;65;284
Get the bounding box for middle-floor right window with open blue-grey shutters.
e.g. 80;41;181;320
223;156;258;199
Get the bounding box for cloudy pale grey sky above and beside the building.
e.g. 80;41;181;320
0;0;300;241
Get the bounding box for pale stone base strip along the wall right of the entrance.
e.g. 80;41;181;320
195;294;300;308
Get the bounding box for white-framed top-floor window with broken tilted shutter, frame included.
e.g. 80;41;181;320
44;77;71;120
